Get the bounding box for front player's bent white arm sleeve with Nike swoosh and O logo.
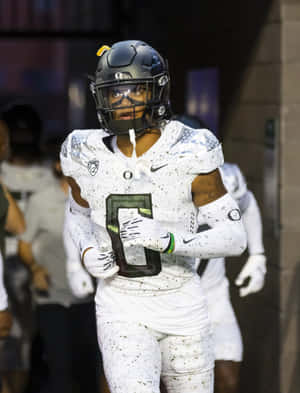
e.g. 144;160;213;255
173;193;247;258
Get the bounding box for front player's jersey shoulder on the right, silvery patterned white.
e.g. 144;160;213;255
165;121;224;174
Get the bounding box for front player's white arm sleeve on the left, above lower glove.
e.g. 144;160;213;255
64;194;97;254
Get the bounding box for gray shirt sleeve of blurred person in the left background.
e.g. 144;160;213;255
19;195;44;243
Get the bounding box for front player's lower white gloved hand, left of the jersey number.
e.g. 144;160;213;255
82;246;119;279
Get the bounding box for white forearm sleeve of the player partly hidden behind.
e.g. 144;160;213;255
243;191;265;255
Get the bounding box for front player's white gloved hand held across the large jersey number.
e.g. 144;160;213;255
120;216;170;252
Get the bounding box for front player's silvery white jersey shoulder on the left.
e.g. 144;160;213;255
60;129;108;176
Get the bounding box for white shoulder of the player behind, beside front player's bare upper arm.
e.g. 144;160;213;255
220;162;248;199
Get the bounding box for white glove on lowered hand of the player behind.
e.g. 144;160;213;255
235;254;267;297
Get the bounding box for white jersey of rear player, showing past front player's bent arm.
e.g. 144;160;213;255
198;162;249;290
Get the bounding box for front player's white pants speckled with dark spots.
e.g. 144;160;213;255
98;319;214;393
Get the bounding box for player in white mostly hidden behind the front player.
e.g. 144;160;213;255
173;114;267;393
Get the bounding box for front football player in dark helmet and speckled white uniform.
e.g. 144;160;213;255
61;41;246;393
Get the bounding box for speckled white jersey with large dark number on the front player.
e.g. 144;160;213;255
61;121;223;296
